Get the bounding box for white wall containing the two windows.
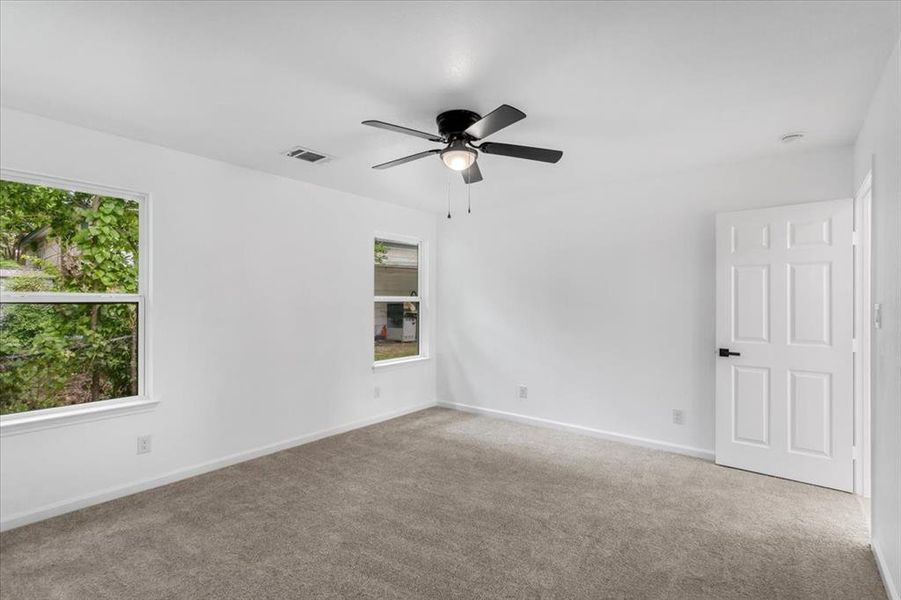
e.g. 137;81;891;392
0;109;435;527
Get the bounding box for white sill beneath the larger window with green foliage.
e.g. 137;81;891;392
0;396;159;437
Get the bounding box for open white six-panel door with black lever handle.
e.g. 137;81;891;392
715;200;854;491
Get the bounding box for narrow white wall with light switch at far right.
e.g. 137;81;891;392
854;42;901;599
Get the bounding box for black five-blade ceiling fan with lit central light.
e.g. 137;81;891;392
363;104;563;184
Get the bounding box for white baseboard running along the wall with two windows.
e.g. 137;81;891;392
0;402;436;531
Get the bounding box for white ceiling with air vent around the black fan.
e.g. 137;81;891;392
0;1;901;211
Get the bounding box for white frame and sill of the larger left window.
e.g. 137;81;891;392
0;169;157;437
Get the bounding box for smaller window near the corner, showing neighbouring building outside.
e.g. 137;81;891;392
374;238;424;364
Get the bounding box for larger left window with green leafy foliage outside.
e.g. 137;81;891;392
0;173;144;415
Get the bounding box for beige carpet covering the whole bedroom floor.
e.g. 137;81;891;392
0;409;885;600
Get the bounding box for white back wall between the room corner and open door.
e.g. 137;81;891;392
438;147;851;456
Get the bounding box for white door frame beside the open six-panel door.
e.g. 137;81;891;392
854;170;873;498
